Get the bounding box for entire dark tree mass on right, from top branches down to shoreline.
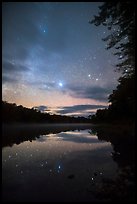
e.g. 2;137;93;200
90;1;135;122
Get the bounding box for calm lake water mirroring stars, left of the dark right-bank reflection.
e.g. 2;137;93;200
2;125;135;202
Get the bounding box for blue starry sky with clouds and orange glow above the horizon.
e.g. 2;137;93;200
2;2;120;116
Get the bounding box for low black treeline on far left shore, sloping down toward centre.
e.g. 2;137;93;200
2;101;91;123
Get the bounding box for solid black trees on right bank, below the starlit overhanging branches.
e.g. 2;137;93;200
89;75;135;123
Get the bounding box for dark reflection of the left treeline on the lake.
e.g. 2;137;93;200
2;124;91;147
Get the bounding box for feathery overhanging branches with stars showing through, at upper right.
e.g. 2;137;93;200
90;1;135;76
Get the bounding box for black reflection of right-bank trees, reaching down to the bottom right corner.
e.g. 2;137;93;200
91;126;135;201
